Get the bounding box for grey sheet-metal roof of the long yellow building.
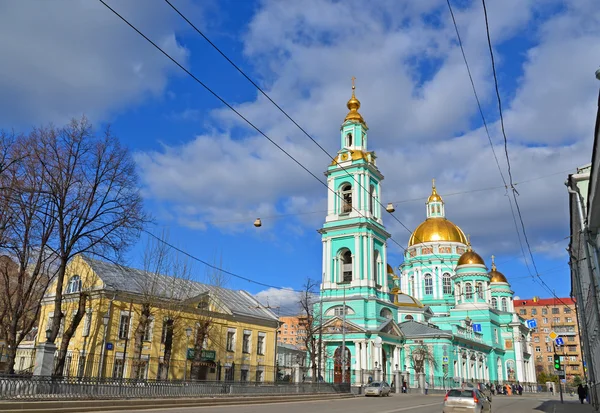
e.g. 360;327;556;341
82;256;278;320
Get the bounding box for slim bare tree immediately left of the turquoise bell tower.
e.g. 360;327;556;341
299;278;323;381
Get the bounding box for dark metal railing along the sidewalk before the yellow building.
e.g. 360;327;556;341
0;376;350;400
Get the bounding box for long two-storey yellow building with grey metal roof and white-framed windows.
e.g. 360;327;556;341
36;255;279;381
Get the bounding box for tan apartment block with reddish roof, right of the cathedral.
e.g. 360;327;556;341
514;297;584;381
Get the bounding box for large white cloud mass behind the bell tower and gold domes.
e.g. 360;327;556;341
138;0;600;262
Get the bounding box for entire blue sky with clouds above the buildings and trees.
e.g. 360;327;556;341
0;0;600;315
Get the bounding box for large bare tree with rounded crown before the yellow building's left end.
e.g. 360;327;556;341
30;117;146;375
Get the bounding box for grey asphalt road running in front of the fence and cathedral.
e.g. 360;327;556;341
98;394;564;413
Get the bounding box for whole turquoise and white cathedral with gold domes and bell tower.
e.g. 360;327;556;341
315;85;536;388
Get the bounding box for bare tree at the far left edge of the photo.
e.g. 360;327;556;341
0;134;56;373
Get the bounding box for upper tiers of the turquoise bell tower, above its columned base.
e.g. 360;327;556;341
319;78;393;298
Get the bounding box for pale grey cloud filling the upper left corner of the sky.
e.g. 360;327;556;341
0;0;192;126
